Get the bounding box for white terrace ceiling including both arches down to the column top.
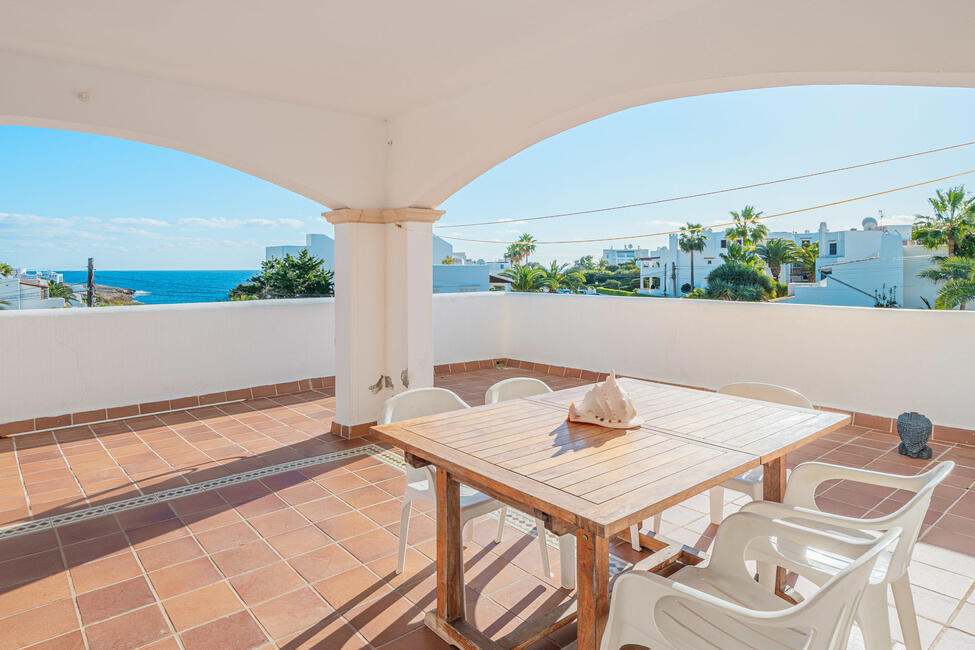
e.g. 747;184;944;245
0;0;975;208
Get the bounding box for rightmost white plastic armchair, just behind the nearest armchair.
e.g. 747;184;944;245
744;461;955;650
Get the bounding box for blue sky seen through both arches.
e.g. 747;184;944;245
0;86;975;270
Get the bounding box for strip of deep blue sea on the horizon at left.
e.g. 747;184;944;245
59;269;258;305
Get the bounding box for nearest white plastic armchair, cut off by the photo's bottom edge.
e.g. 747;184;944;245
601;513;900;650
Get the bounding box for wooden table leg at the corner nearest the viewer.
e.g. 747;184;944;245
576;529;609;650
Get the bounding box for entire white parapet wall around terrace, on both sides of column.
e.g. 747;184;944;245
0;293;975;428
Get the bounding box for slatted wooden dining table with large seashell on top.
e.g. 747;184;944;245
372;378;850;650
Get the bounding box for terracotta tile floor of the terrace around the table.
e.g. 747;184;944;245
0;370;975;649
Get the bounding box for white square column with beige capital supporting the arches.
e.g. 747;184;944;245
324;208;443;437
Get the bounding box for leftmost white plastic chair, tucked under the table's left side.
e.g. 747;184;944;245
378;388;508;573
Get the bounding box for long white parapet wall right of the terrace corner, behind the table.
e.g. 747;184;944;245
505;293;975;429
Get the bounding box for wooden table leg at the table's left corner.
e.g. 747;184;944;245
437;468;464;622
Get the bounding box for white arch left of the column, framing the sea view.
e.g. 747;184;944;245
0;52;386;208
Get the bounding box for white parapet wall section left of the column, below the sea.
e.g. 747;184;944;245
0;298;335;422
